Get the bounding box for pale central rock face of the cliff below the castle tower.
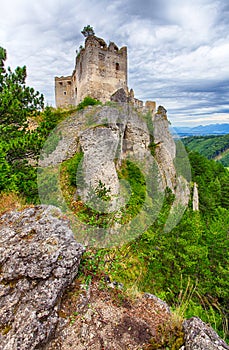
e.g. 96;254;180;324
78;105;150;211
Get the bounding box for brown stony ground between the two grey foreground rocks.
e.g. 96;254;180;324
47;279;183;350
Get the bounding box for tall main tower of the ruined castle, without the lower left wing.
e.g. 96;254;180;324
74;36;127;104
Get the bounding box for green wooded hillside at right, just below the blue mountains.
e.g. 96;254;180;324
182;134;229;167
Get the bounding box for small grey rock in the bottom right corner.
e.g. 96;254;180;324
181;317;229;350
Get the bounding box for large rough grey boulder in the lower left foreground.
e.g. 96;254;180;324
0;206;84;350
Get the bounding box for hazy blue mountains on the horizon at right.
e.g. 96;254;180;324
173;123;229;137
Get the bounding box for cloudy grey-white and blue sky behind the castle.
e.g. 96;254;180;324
0;0;229;126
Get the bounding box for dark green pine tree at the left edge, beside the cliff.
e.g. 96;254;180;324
0;47;44;200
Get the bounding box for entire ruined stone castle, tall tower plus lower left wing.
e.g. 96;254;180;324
55;35;128;107
